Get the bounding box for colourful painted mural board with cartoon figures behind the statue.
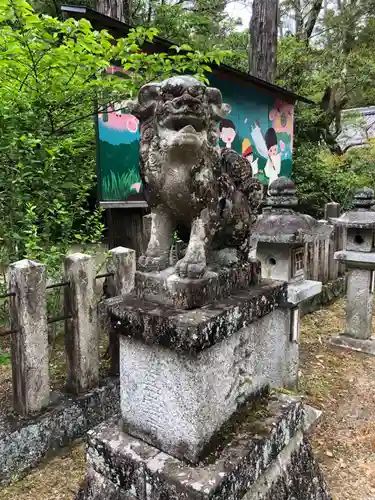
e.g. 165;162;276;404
97;67;294;202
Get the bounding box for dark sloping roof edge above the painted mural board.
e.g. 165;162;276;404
60;5;316;104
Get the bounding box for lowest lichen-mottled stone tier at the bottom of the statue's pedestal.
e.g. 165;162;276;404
77;395;331;500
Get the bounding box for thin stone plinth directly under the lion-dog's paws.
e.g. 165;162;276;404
136;262;260;309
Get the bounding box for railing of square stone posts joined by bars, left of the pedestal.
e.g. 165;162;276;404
0;247;135;417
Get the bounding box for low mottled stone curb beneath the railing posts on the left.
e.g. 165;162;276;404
0;379;120;484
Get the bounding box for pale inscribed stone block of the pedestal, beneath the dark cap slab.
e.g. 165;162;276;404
120;309;298;463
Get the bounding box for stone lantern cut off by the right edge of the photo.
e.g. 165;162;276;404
331;188;375;355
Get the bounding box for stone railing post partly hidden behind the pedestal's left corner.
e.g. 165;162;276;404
107;247;136;375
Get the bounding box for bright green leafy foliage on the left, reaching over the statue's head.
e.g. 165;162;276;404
0;0;226;271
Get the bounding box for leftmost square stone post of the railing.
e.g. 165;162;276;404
8;259;50;416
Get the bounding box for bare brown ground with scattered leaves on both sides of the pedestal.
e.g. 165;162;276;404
0;301;375;500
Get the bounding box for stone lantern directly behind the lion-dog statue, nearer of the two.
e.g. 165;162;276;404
250;177;333;344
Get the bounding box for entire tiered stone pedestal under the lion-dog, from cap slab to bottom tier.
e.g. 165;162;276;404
78;264;331;500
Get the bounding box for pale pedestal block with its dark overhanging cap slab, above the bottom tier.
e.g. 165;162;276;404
108;282;298;463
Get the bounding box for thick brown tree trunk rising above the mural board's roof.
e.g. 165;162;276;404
249;0;279;83
